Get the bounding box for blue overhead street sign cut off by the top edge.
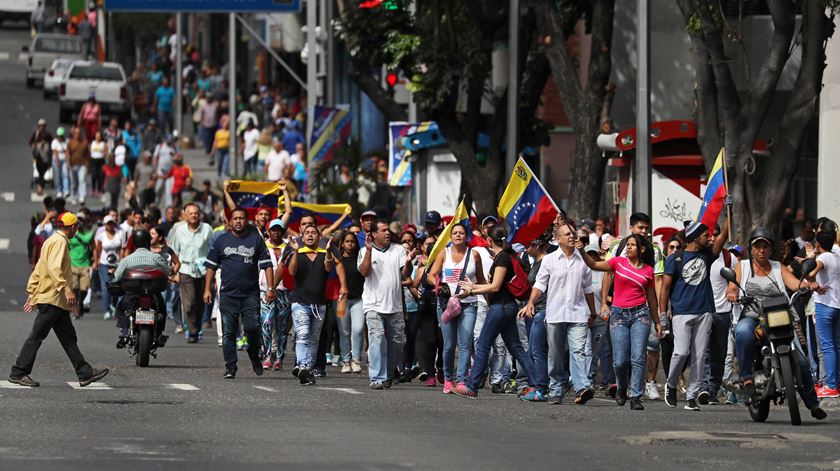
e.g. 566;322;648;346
105;0;301;13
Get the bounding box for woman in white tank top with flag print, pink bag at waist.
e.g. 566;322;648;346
426;223;485;394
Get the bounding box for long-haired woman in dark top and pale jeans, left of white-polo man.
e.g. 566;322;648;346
338;231;365;373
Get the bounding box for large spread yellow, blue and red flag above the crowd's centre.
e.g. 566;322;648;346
498;157;560;245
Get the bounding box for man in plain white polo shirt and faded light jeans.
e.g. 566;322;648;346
360;220;414;389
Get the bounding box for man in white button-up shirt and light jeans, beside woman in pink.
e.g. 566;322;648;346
520;224;595;404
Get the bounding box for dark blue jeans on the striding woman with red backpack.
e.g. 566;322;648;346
469;303;546;391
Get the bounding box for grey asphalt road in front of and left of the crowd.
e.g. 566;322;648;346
0;23;840;470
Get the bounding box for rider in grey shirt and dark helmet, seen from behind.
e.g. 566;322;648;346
114;229;172;348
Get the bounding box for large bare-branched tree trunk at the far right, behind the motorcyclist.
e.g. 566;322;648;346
677;0;837;241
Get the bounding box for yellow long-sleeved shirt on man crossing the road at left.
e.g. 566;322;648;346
26;231;73;311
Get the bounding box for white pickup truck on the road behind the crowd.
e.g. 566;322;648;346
58;61;131;123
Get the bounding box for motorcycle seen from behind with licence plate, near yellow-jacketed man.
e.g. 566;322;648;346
108;268;168;367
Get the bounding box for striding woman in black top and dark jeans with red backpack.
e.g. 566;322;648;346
453;226;548;401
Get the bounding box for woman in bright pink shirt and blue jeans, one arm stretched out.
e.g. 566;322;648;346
577;234;662;410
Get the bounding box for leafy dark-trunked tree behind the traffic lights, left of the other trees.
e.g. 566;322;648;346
339;0;552;212
